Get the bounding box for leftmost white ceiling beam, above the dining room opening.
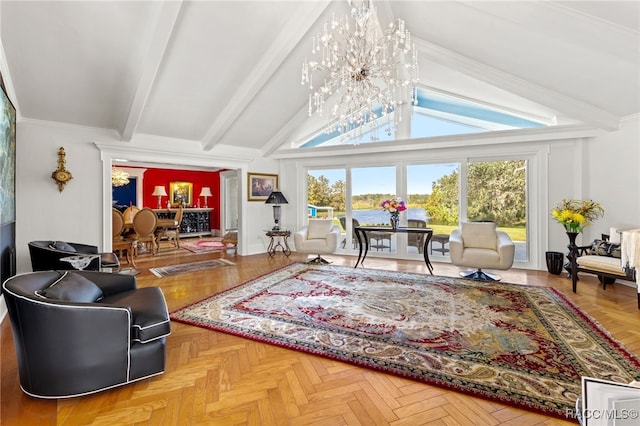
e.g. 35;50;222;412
121;0;182;142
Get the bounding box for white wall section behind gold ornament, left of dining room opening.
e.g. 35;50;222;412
16;122;112;273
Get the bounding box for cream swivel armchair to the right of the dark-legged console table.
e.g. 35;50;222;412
449;222;515;281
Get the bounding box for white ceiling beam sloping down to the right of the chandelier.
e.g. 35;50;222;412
413;37;620;131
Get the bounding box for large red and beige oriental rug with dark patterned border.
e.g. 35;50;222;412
171;263;640;420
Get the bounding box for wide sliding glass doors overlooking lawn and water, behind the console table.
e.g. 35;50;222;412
307;158;530;262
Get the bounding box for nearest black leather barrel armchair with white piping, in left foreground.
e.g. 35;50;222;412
2;271;171;398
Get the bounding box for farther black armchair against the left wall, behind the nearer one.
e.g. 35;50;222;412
29;241;120;271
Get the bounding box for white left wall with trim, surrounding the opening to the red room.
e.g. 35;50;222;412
16;121;278;273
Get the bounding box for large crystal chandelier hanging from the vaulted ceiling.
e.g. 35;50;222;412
302;0;418;140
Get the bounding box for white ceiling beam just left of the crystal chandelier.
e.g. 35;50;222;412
202;0;331;150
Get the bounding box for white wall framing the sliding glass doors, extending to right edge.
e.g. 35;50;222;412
281;117;640;270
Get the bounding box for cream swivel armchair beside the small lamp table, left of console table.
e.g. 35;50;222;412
293;219;341;263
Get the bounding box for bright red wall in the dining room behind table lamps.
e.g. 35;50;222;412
134;168;220;229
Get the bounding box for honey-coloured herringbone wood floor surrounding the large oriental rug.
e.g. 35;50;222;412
0;249;640;426
